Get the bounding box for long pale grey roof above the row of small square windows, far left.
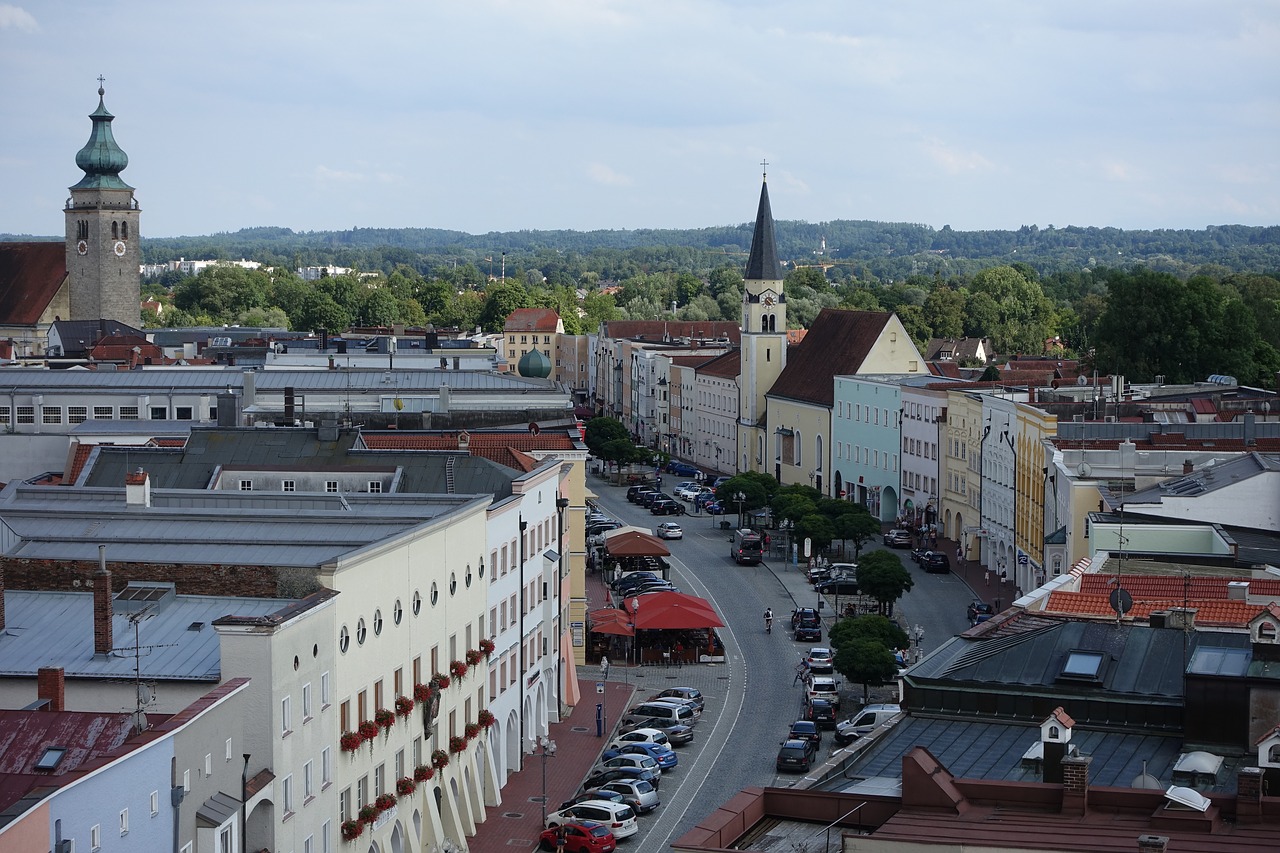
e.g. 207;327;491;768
0;366;563;397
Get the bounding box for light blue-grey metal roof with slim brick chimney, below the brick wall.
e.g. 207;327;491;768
0;589;297;681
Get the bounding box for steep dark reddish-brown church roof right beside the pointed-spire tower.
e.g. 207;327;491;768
767;309;893;407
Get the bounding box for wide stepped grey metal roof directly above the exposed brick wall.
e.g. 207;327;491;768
0;483;477;567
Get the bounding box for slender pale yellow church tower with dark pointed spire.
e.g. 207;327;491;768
737;166;787;471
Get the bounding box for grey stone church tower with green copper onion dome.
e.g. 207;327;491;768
65;77;142;327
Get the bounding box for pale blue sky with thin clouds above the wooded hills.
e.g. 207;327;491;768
0;0;1280;237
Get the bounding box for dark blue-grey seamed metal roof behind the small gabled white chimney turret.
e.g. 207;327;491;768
826;712;1240;793
